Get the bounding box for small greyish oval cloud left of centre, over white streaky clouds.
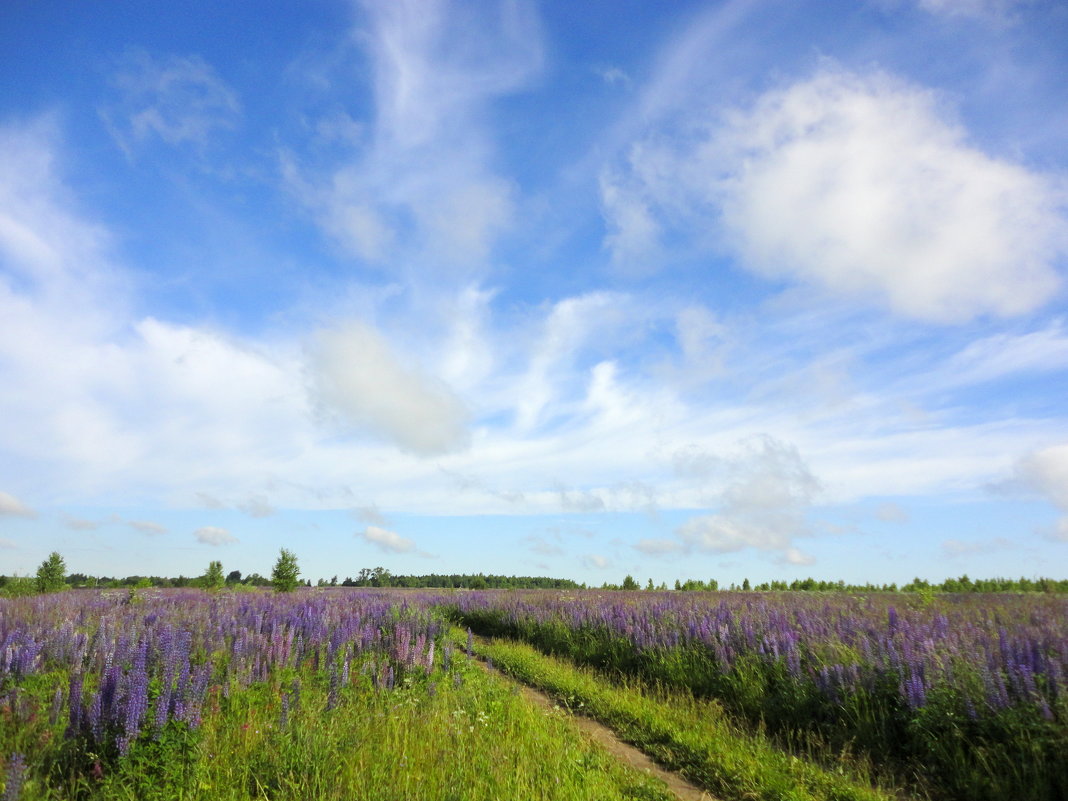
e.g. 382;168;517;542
308;323;469;456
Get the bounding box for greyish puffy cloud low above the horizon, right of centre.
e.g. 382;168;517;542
676;437;821;564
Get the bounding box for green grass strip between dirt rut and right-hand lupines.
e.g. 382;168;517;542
453;629;918;801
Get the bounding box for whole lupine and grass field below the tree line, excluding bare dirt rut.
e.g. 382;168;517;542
0;590;1068;801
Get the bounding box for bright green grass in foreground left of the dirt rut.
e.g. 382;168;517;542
0;655;672;801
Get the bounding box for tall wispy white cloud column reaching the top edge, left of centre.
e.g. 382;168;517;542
284;0;541;273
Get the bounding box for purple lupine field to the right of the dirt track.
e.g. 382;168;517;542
442;593;1068;801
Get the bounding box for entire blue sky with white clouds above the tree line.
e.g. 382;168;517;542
0;0;1068;586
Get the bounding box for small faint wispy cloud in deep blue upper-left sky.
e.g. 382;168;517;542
101;50;241;153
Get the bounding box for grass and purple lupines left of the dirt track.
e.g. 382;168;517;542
0;592;670;801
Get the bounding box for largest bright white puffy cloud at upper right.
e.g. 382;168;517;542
604;66;1068;323
